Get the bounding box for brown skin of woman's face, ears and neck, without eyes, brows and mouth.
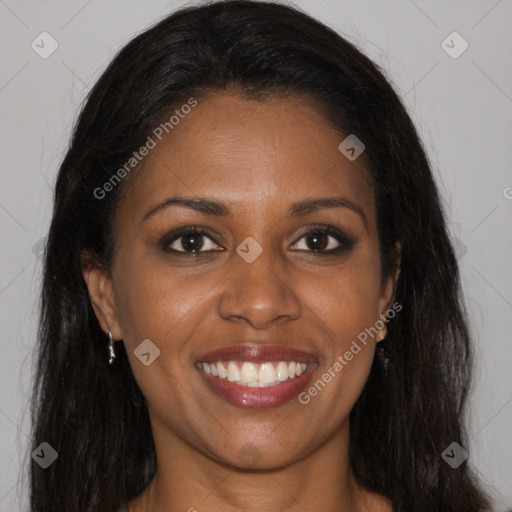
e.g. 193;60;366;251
84;93;393;512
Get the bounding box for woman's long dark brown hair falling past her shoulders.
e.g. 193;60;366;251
30;0;489;512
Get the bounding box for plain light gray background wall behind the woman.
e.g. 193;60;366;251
0;0;512;512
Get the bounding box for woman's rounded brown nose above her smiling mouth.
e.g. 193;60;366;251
219;246;301;330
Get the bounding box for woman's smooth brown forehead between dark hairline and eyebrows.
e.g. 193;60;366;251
116;93;373;218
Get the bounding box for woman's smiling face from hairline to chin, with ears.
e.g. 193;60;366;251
86;93;392;468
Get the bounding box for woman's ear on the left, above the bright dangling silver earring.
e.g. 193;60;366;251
82;254;122;340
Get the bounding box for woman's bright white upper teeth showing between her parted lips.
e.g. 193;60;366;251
198;361;308;388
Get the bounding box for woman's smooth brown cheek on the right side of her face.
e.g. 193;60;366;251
294;252;380;408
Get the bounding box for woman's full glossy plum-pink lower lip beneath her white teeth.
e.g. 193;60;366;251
196;363;317;409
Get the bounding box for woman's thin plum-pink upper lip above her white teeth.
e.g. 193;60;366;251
197;345;316;363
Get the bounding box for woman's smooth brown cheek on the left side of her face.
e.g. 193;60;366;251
111;258;215;418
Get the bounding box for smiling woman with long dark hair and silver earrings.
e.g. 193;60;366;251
31;0;496;512
